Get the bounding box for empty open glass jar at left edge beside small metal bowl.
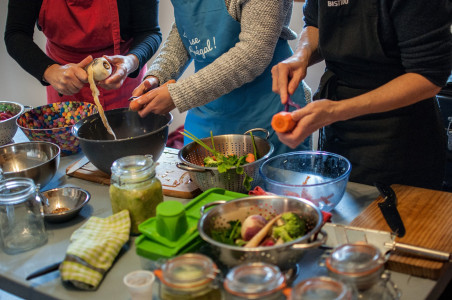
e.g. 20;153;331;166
0;178;47;254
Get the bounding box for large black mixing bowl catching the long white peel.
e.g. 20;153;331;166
72;108;173;174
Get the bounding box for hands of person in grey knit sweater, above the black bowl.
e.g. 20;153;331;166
132;76;176;117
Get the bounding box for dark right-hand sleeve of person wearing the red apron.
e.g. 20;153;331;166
118;0;162;77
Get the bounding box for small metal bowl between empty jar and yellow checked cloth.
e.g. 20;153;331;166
41;187;91;223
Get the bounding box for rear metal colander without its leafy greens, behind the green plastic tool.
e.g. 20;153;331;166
177;128;274;193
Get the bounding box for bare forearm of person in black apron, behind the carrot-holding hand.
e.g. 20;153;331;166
334;73;441;121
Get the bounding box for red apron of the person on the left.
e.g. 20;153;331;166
39;0;146;110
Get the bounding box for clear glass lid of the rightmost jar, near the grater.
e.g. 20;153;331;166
326;243;385;276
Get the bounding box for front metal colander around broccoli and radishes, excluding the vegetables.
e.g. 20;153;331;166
198;196;326;270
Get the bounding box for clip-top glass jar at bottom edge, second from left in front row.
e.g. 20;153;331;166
223;262;286;300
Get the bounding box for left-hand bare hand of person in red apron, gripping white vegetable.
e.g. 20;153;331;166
43;55;93;95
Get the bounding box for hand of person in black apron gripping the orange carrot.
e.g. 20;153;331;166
276;99;340;149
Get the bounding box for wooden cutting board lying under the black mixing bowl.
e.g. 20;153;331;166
66;148;201;199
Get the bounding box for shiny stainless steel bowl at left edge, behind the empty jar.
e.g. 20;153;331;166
0;141;61;187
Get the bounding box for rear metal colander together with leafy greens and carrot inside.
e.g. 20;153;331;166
177;128;274;193
